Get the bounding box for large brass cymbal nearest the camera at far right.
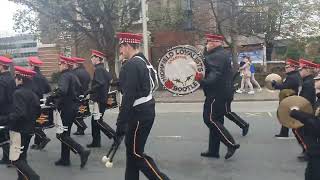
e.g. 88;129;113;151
277;96;313;129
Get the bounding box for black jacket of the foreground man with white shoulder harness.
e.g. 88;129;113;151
117;53;151;129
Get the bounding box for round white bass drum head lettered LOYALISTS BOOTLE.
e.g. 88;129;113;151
158;45;205;95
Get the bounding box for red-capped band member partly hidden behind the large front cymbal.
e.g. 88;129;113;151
292;59;318;160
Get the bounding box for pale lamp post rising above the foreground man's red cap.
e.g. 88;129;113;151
141;0;149;58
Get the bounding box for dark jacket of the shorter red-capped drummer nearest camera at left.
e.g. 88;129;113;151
9;81;41;134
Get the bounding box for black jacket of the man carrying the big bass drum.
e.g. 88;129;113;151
200;46;234;99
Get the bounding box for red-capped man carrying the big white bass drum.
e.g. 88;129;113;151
196;34;240;159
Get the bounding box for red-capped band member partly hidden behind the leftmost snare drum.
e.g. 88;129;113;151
28;57;51;150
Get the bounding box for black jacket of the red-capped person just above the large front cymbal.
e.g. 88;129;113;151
299;75;316;107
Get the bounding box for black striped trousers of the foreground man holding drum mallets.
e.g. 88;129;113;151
125;100;169;180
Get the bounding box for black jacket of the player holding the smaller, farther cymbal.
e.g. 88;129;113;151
274;71;301;94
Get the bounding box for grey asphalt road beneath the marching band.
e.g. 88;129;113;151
0;102;306;180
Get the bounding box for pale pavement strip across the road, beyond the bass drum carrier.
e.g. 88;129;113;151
155;88;279;103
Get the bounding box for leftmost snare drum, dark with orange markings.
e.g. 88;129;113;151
36;104;54;129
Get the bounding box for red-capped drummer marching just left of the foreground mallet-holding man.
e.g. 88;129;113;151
87;50;115;148
